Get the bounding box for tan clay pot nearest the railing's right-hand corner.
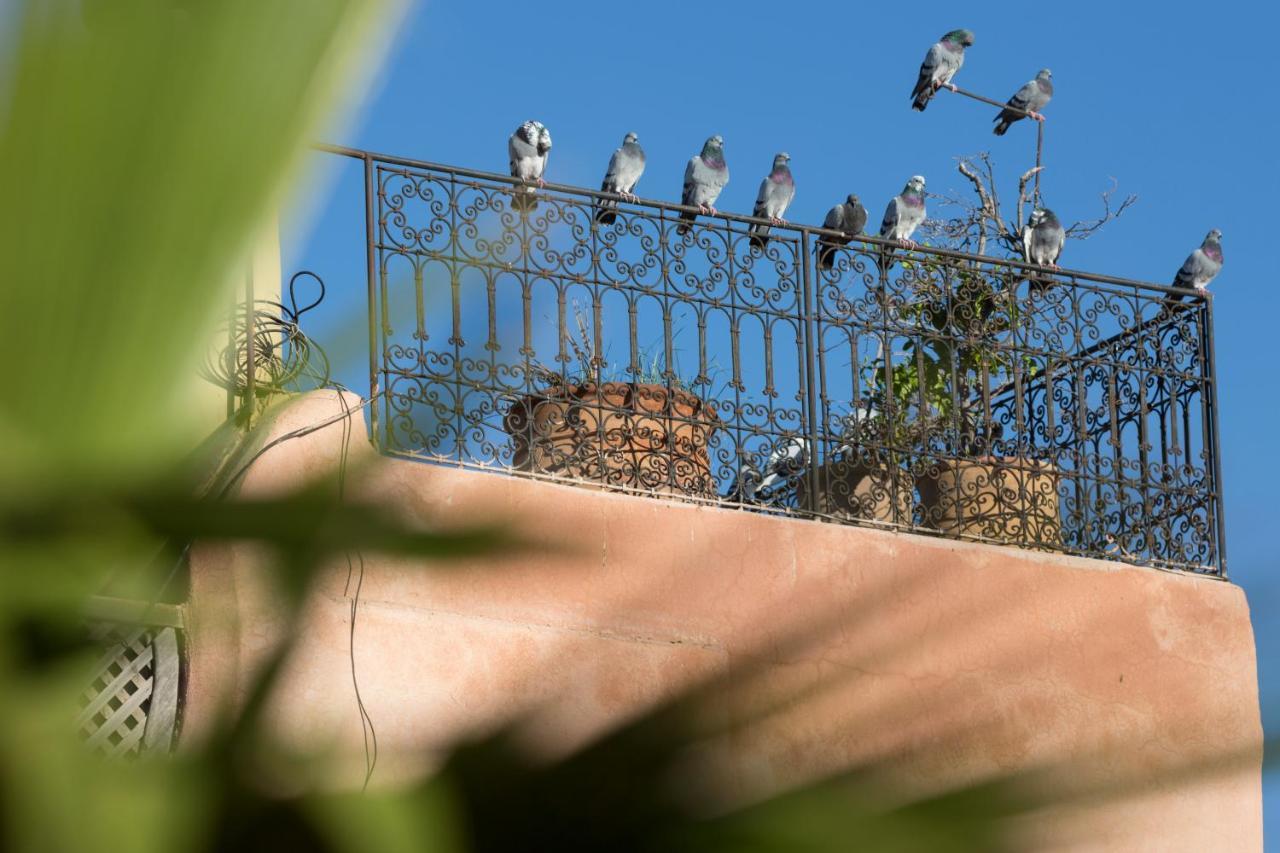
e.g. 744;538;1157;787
916;456;1062;549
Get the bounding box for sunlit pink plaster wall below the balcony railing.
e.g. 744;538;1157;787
184;393;1262;850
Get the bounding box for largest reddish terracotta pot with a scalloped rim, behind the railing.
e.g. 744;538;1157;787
503;382;719;497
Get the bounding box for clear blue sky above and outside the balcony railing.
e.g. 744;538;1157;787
284;0;1280;835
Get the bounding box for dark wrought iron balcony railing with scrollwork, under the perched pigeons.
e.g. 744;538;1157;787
317;149;1225;575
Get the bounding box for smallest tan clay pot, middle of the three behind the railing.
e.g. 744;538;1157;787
796;457;915;524
